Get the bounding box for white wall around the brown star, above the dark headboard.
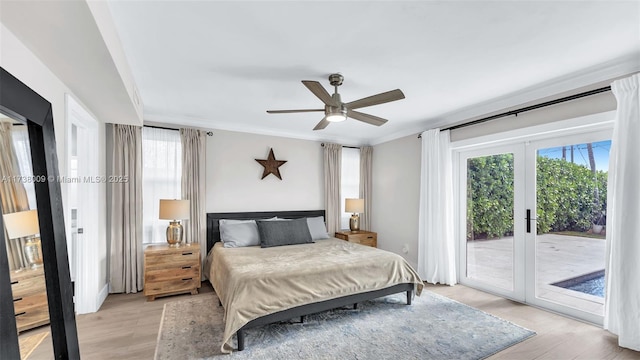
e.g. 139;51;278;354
206;130;324;212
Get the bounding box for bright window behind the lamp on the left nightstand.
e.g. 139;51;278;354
142;127;182;244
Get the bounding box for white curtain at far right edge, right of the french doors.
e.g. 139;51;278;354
604;74;640;351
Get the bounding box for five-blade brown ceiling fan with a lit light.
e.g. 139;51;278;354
267;74;404;130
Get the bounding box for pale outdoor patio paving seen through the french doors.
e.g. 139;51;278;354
467;234;605;315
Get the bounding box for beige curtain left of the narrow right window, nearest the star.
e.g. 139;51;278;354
323;144;342;236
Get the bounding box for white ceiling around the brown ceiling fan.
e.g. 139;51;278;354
109;1;640;144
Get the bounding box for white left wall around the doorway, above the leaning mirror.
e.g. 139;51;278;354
0;24;107;310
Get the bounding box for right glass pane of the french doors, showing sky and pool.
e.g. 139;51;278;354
536;140;611;315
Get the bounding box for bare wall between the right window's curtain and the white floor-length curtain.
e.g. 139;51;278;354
371;135;422;266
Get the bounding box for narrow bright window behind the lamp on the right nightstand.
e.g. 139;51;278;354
340;147;360;229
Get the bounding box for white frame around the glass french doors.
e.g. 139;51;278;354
451;111;616;325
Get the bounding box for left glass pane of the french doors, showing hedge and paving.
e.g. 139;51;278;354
466;153;514;291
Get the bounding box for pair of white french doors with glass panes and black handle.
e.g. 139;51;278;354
458;126;611;324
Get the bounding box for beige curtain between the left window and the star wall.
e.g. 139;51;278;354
180;129;207;268
